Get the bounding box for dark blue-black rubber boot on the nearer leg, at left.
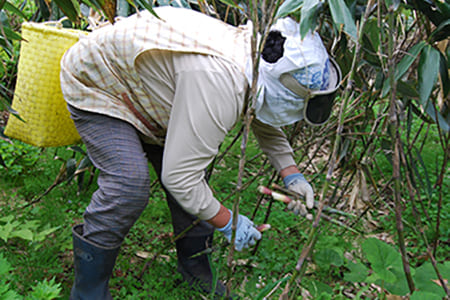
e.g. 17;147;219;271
70;225;120;300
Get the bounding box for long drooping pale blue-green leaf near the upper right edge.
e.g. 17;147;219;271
418;45;440;106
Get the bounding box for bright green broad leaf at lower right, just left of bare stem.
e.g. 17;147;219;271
361;238;401;283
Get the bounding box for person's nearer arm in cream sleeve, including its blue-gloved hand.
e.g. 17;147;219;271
162;56;261;251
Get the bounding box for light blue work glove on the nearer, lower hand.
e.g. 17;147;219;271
217;210;261;251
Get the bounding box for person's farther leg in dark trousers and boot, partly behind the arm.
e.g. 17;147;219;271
144;144;232;296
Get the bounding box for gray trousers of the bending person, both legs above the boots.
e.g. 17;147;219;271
68;105;214;247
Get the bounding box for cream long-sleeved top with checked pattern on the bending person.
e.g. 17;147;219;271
61;7;295;219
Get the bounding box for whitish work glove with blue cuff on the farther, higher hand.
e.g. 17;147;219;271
283;173;314;216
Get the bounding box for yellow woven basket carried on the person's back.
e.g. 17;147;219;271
4;22;87;147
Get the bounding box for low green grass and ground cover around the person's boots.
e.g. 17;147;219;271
0;118;449;299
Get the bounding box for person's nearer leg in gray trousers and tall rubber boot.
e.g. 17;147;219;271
69;107;150;299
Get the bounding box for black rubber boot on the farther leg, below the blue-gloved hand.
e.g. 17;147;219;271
175;234;239;299
